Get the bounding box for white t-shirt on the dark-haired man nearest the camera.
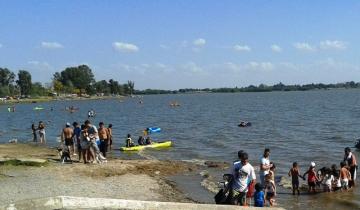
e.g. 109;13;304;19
231;161;256;192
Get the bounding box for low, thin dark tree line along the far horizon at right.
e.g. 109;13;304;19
135;81;360;94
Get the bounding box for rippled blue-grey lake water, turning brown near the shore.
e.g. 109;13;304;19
0;90;360;209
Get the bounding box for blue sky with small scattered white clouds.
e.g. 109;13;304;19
0;0;360;90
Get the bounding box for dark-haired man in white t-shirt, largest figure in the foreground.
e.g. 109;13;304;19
231;151;256;206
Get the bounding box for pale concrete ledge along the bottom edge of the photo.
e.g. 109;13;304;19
0;196;282;210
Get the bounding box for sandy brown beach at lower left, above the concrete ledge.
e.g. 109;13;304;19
0;144;196;204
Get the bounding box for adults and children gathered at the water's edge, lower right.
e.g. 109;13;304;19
225;147;358;207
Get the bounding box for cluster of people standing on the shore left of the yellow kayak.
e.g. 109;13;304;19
61;120;113;163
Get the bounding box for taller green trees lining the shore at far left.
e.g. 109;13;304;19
0;65;135;97
